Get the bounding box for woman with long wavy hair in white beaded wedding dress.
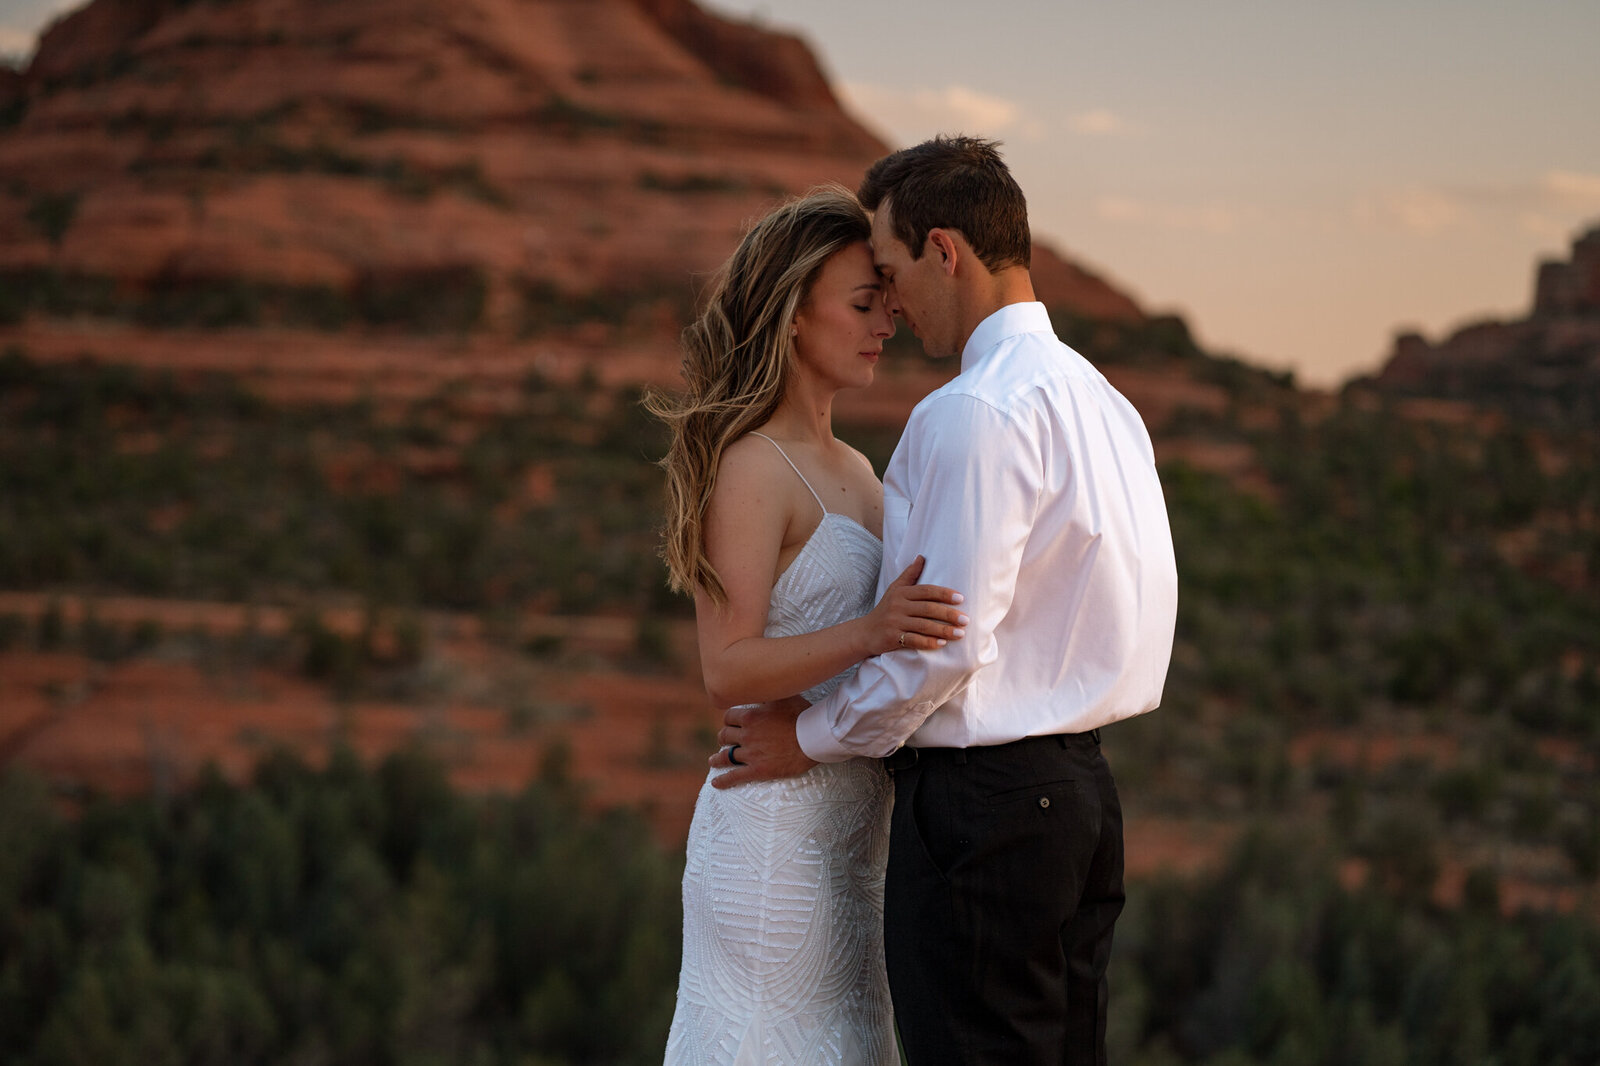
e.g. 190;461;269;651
650;187;966;1066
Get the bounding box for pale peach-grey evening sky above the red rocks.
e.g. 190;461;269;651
9;0;1600;386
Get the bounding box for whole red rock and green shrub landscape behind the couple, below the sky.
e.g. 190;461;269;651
0;0;1600;1066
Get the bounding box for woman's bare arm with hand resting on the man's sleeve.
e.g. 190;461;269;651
694;442;966;707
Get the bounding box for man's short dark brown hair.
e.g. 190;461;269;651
856;136;1034;272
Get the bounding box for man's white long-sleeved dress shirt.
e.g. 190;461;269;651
795;303;1178;762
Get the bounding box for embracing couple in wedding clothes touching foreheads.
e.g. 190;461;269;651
654;138;1178;1066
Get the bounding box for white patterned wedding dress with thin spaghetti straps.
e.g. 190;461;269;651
666;439;899;1066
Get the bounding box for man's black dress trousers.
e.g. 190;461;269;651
885;733;1123;1066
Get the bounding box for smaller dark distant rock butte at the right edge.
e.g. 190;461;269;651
1370;226;1600;426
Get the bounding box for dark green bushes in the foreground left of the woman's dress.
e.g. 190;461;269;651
0;752;677;1066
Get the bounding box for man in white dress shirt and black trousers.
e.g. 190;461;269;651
712;138;1178;1066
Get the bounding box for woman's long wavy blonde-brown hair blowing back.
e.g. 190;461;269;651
645;186;872;603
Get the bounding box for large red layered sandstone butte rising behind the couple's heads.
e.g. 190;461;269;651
0;0;1142;336
